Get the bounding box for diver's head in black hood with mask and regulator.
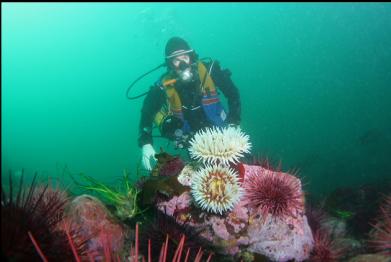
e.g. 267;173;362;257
166;37;197;82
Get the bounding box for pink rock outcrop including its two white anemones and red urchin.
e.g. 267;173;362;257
142;127;314;261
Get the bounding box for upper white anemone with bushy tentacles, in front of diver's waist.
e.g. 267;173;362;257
189;127;251;165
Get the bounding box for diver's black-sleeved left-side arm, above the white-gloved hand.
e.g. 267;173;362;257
137;86;165;147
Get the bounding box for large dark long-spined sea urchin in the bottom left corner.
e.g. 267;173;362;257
1;170;87;261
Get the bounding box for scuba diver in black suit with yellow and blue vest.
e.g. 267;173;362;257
138;37;241;171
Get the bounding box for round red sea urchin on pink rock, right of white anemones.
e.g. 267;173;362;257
243;165;304;218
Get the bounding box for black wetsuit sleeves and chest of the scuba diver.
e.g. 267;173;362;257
138;61;241;147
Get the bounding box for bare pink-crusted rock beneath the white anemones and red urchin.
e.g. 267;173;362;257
157;165;314;261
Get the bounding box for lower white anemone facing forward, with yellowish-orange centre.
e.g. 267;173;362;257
191;165;243;215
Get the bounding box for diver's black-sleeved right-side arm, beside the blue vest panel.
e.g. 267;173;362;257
211;60;241;125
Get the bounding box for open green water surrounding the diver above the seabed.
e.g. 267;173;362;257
1;3;391;196
